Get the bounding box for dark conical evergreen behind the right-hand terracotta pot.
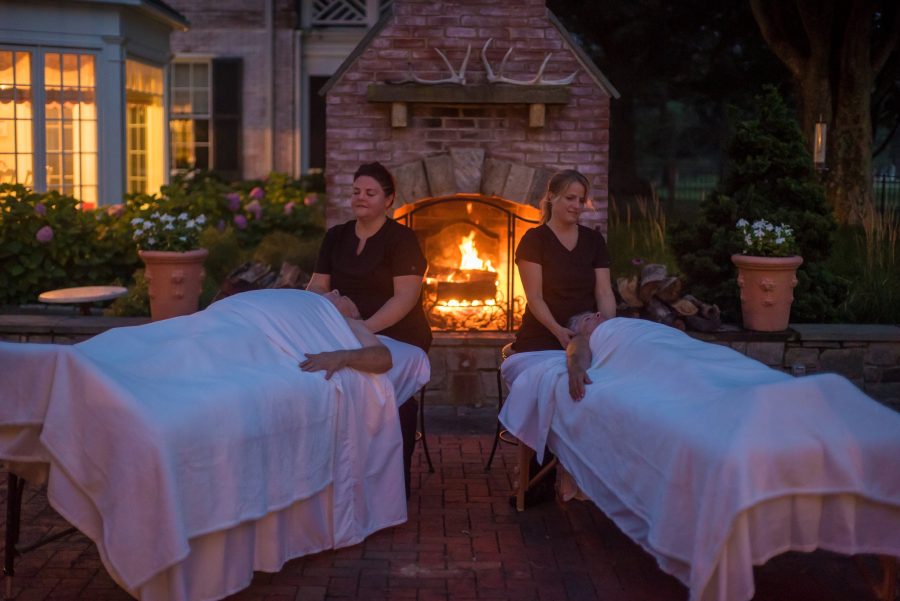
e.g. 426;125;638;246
672;87;846;322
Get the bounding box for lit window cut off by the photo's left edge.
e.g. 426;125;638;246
0;50;34;186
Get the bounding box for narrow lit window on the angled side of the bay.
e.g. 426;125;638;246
125;60;165;193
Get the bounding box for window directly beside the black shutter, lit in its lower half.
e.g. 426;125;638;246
169;61;212;169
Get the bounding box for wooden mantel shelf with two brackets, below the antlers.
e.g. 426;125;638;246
366;83;571;127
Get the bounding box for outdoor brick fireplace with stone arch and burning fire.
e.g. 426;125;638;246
323;0;618;405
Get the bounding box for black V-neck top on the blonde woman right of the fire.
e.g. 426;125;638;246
513;224;609;352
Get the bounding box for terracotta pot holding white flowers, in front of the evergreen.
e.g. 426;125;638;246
731;255;803;332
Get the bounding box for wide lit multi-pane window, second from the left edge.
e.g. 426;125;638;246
44;52;97;207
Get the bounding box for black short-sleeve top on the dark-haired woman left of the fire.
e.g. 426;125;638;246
315;219;431;351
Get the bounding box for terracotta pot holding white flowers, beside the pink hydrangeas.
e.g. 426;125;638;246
138;248;209;321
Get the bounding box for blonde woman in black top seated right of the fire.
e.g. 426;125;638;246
513;169;616;352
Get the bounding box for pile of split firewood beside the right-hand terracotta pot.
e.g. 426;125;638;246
616;263;722;332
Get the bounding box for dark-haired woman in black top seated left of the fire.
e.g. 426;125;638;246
307;162;431;497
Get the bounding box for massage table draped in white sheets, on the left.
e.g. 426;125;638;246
0;290;430;601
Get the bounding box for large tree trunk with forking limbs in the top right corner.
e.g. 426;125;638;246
750;0;900;223
